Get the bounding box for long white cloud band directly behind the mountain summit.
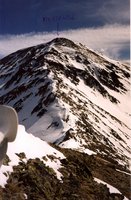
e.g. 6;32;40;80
0;24;130;59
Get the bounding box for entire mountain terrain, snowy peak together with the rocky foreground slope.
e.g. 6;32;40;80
0;38;131;200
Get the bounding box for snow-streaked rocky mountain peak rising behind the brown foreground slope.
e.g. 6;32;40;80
0;38;131;199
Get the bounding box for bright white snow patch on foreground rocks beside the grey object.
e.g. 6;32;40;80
0;125;65;187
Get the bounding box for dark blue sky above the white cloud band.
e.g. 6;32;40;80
0;0;130;34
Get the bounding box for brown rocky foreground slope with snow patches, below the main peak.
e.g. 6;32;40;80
0;125;130;200
